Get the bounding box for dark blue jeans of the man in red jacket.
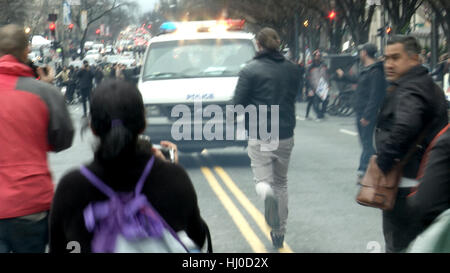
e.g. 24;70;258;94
0;211;48;253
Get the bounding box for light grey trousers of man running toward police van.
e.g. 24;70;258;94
248;138;294;235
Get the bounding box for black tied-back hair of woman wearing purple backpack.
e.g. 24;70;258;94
90;80;145;163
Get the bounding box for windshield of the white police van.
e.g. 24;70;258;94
142;39;256;81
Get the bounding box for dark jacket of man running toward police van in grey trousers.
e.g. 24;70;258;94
233;51;300;139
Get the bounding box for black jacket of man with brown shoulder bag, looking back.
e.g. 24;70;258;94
375;65;448;179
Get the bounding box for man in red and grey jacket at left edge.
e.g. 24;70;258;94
0;25;74;253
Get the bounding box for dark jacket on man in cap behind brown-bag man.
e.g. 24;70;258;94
342;62;387;122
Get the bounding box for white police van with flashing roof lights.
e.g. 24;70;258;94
138;20;257;152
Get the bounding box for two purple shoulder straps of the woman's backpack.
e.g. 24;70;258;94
80;156;155;198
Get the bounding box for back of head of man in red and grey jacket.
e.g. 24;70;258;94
0;24;29;59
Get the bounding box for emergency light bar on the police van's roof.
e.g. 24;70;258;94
160;19;245;34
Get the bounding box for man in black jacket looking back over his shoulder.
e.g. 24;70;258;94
375;36;448;252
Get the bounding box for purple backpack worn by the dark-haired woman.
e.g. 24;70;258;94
81;156;195;253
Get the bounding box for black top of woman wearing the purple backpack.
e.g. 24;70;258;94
50;148;209;253
